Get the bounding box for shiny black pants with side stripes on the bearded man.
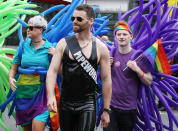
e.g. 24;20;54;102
59;101;96;131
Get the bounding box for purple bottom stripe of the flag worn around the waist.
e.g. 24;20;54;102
16;86;48;125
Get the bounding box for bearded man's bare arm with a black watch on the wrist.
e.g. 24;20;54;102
98;40;112;128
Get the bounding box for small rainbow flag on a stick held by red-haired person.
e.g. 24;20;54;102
144;39;172;75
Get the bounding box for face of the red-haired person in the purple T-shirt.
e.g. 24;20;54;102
115;30;133;47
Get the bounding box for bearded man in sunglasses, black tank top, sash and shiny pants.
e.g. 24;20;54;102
46;5;112;131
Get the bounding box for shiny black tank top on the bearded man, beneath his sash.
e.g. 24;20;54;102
61;37;98;102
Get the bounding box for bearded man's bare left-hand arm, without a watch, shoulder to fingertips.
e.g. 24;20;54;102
46;39;66;112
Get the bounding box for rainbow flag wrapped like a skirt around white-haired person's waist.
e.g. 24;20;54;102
16;74;47;125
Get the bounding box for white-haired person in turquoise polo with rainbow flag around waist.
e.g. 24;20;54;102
9;16;55;131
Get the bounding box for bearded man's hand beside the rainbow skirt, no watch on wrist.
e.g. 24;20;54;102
47;96;57;113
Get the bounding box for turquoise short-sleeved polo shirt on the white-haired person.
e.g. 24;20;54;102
13;40;52;68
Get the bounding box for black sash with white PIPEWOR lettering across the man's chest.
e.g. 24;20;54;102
65;35;100;92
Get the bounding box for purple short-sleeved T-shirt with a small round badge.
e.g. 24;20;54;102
111;49;149;110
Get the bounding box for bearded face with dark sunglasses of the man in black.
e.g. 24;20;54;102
73;10;94;33
